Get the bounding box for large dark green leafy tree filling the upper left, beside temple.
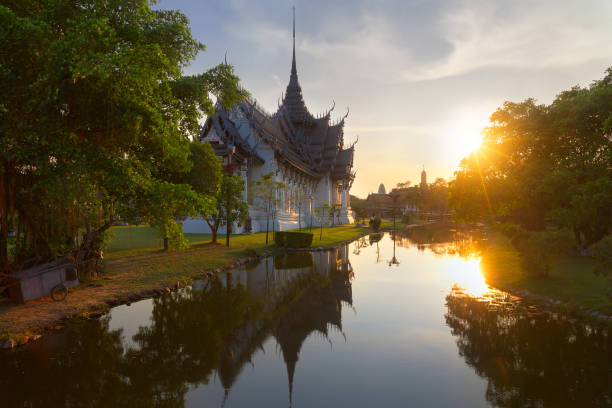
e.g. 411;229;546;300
0;0;245;270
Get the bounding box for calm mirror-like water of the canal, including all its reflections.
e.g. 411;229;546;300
0;228;612;407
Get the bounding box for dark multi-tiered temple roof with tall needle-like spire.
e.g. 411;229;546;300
200;12;354;181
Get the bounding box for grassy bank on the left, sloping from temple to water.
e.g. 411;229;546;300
0;226;371;348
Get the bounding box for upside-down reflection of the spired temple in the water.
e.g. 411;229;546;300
210;246;353;404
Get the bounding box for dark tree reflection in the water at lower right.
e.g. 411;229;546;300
445;291;612;407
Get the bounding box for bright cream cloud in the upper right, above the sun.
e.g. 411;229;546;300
404;1;612;81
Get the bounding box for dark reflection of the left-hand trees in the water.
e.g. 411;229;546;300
0;280;260;407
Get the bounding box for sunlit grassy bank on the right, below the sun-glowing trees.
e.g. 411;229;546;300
481;233;612;314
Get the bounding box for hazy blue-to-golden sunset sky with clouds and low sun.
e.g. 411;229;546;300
156;0;612;197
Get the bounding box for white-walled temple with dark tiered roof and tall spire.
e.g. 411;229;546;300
183;11;355;233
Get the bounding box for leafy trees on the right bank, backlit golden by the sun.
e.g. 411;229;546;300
450;68;612;249
